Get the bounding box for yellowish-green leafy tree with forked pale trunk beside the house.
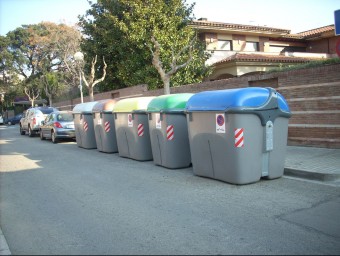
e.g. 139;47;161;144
115;0;208;94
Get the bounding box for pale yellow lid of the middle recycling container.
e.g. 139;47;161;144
113;97;155;113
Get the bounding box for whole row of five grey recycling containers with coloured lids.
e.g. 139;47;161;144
73;87;291;184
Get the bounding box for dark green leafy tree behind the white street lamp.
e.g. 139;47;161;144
80;1;152;91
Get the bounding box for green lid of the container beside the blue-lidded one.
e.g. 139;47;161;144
148;93;194;112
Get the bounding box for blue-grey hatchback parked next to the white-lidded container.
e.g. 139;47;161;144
40;111;76;143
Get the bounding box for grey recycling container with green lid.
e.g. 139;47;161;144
148;93;193;169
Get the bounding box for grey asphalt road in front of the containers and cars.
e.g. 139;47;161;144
0;125;340;254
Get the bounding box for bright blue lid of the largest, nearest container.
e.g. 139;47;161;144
186;87;290;112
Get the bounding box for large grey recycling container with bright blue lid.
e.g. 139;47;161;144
186;87;291;184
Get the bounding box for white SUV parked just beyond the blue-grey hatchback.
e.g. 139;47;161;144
20;107;58;137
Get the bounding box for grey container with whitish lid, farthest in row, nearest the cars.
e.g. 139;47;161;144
72;101;97;149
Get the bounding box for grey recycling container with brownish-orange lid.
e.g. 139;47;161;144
92;99;118;153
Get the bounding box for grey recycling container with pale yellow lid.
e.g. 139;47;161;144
113;97;155;161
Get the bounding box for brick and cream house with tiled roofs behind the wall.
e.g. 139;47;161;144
191;18;340;81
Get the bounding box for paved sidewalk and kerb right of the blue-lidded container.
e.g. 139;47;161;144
284;146;340;181
